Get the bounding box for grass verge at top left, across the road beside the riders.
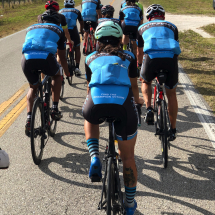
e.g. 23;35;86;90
0;0;81;38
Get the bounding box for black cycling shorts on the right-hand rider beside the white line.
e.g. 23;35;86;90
140;54;178;89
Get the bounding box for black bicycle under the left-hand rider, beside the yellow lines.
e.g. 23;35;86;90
30;71;57;165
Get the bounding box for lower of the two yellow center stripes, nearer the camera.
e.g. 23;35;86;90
0;96;27;137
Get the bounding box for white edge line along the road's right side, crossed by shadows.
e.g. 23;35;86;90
179;64;215;148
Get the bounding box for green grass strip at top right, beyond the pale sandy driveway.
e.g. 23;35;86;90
140;0;215;16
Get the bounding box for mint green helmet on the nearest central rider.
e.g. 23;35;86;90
95;21;123;42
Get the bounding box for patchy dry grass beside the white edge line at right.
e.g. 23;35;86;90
179;30;215;114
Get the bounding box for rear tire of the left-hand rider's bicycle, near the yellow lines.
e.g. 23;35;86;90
31;98;44;165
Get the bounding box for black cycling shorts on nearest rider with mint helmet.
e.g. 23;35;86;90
82;89;138;140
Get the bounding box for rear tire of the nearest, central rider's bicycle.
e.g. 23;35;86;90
106;157;115;215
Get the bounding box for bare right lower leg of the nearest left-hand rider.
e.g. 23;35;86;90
51;71;62;102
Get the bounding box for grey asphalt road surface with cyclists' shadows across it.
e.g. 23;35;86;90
0;0;215;215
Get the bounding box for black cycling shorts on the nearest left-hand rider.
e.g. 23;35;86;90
21;54;59;85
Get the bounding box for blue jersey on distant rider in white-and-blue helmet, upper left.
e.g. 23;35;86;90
59;8;80;29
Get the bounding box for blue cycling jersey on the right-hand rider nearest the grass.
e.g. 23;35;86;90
138;20;181;59
